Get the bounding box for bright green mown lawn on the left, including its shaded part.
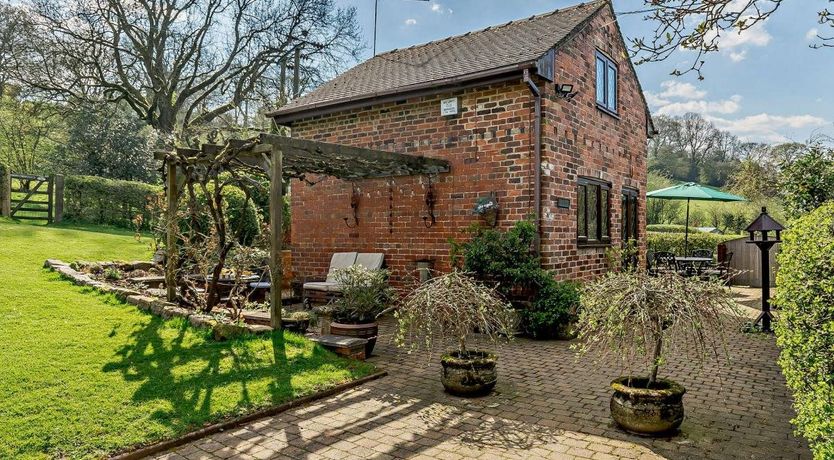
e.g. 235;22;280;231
0;219;373;458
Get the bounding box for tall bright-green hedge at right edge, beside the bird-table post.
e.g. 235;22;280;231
774;202;834;459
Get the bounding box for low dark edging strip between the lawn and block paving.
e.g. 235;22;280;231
110;371;388;460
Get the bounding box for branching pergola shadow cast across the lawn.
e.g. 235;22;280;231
103;316;364;434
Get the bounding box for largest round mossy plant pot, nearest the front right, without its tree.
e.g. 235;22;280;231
611;377;686;436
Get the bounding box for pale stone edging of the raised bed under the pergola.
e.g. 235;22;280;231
43;259;272;334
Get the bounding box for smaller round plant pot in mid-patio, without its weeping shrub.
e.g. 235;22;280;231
440;351;498;396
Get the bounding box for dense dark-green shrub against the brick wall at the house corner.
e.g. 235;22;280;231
452;221;579;339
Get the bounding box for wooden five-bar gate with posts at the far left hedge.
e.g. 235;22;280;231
0;169;64;223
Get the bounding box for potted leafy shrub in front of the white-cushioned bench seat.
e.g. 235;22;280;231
326;265;395;356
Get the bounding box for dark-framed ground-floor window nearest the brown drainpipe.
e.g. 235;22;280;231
576;177;611;246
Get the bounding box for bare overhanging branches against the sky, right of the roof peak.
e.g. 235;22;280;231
620;0;834;79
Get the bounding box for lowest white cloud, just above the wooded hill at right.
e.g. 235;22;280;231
705;112;829;143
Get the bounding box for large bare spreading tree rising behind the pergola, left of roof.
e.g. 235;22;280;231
20;0;359;141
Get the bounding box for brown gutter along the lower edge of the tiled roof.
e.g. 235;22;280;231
266;61;536;125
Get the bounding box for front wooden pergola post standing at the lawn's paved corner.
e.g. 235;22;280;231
269;148;284;330
